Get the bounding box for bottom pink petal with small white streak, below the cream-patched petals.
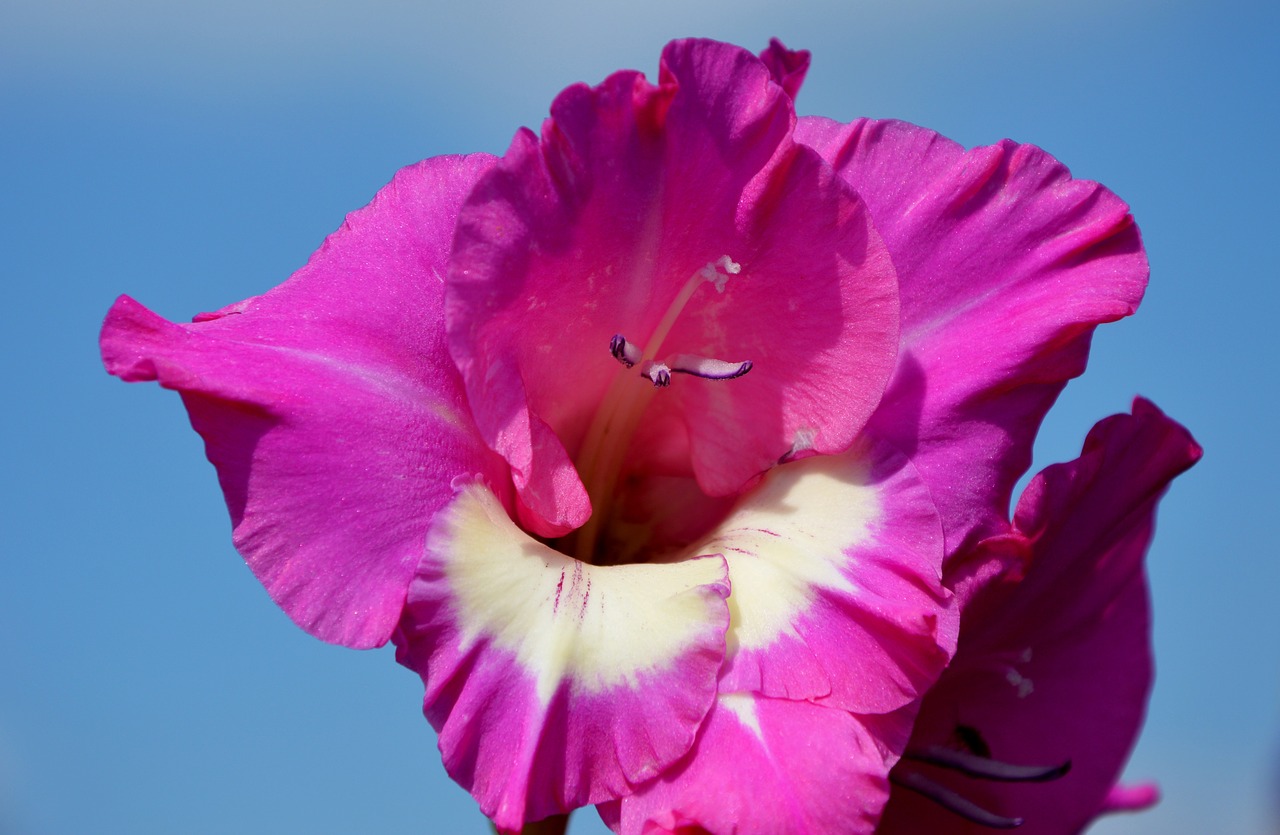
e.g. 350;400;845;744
600;693;888;835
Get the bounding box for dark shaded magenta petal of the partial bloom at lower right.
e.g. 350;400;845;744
882;400;1201;835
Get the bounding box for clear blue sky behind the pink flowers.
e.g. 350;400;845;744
0;0;1280;835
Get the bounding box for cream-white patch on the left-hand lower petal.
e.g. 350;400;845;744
428;484;728;704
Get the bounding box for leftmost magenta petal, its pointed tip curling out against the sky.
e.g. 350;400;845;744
101;156;507;647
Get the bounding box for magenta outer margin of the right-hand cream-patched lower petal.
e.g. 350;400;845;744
713;443;959;717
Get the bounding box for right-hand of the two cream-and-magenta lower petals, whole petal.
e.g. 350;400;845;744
711;432;957;713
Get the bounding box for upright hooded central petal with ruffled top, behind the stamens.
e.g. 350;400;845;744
447;41;897;535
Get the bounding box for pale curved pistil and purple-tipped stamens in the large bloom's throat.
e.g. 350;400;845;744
566;255;751;562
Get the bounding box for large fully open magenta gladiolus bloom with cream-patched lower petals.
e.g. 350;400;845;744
101;41;1187;834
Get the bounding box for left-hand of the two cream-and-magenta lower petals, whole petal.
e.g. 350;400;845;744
396;484;728;831
